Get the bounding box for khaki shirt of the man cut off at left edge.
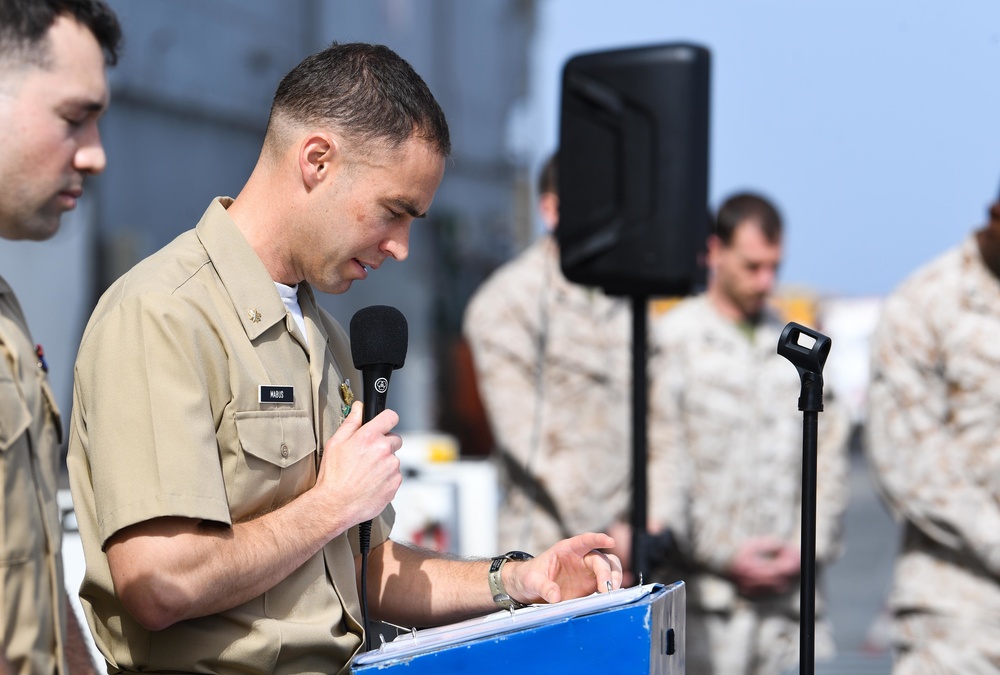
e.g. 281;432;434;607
0;279;67;674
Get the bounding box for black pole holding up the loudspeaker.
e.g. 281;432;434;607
631;295;649;583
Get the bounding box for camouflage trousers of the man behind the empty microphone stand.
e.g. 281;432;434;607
684;606;835;675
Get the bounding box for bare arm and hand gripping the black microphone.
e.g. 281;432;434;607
107;402;402;630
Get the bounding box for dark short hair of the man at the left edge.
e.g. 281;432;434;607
0;0;122;68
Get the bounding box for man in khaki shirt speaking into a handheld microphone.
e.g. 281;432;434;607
69;44;621;673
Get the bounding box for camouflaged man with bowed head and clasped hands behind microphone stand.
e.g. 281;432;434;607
649;193;849;675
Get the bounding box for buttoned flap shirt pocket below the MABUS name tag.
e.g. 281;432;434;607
226;410;317;520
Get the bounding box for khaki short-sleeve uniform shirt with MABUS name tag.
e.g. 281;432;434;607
68;199;393;673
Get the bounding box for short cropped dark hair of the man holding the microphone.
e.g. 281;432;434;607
268;42;451;157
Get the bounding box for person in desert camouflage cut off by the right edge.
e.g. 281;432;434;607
866;202;1000;675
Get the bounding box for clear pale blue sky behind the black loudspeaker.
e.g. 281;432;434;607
513;0;1000;295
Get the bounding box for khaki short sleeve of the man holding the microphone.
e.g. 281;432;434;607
76;296;230;545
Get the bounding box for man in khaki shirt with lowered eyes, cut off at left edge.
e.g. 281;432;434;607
0;0;121;675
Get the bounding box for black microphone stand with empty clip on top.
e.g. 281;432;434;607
778;322;831;675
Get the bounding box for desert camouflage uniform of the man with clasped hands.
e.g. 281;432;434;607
649;295;850;675
